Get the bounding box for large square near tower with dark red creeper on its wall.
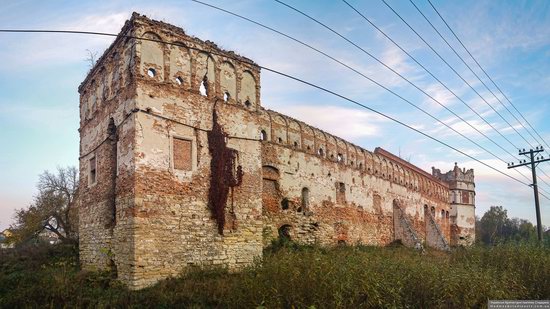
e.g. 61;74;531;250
79;13;263;288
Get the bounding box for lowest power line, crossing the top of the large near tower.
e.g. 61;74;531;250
0;25;550;200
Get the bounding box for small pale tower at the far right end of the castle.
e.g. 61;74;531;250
432;163;476;246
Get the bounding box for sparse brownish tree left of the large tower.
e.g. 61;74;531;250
10;167;78;244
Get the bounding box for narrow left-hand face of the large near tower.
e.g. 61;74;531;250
79;15;136;280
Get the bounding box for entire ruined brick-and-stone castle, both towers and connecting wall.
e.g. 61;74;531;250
79;13;475;288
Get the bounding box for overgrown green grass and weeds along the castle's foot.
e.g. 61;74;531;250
0;242;550;308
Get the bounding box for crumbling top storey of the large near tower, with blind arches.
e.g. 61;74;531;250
79;13;266;125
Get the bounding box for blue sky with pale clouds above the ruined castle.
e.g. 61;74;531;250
0;0;550;229
